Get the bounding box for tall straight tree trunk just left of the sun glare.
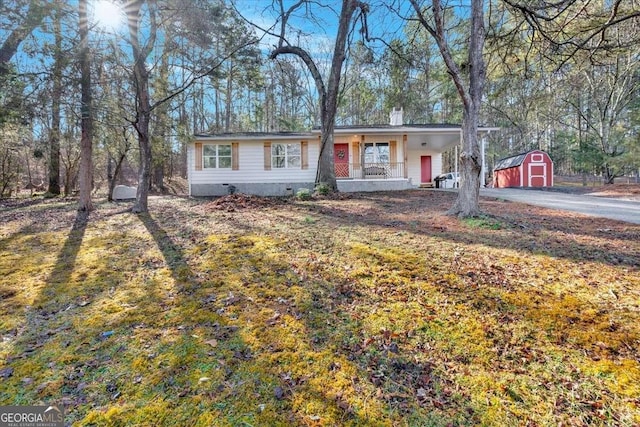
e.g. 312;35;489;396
78;0;93;211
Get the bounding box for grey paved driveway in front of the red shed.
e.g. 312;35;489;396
480;188;640;224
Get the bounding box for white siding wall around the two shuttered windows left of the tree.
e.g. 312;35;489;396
187;138;319;186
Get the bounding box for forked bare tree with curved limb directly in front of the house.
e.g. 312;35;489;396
269;0;369;191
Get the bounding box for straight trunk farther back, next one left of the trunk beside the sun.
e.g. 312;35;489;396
47;2;63;195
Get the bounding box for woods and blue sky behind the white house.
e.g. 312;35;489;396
0;0;640;202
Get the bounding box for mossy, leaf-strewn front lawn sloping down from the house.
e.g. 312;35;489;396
0;191;640;426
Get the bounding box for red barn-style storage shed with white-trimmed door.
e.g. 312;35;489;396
493;150;553;188
